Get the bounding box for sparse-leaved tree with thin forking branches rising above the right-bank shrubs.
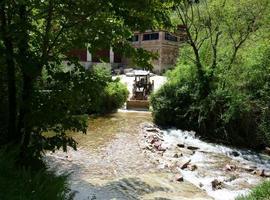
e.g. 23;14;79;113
176;0;269;98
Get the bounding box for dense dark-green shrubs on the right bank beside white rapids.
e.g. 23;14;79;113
151;49;270;148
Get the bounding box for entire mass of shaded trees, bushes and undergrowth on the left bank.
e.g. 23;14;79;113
0;0;173;199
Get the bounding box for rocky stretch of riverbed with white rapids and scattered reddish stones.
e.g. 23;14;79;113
139;123;270;200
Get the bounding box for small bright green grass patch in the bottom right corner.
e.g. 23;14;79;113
236;181;270;200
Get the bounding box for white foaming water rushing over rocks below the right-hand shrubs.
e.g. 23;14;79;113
151;129;270;200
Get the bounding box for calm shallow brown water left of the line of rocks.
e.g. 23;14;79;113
45;112;211;200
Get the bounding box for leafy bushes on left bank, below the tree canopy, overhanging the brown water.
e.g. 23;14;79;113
25;64;128;159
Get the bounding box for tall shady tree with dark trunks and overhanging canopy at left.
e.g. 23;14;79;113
0;0;173;162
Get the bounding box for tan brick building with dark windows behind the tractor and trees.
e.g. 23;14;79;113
68;26;186;74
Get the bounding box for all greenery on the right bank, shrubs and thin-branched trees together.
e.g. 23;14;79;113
151;0;270;148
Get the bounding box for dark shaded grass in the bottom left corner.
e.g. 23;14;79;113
0;149;72;200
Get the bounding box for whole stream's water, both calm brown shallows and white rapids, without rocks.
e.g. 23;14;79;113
44;112;270;200
